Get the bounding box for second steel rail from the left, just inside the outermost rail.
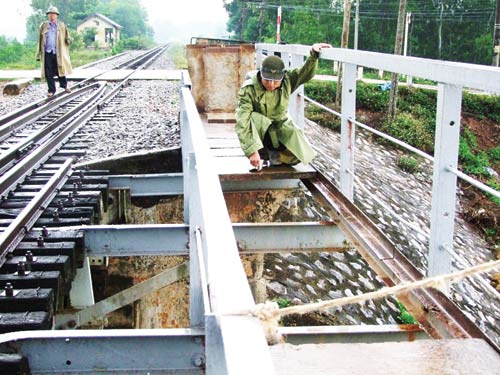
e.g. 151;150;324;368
0;83;102;168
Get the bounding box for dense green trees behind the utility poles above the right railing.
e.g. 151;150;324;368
224;0;496;64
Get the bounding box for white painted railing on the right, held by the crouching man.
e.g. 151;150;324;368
256;43;500;276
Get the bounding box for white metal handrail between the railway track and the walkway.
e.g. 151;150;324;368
180;72;274;375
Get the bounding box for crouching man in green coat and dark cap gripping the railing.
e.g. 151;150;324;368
236;43;332;170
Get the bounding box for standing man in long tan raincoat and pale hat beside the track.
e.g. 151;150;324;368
36;5;72;98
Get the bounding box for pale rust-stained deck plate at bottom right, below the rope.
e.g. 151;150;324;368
271;339;500;375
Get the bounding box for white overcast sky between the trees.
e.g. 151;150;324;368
0;0;228;42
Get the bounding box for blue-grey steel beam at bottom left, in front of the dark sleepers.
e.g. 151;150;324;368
0;329;204;374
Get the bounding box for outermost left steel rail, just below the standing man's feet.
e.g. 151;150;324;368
0;83;96;140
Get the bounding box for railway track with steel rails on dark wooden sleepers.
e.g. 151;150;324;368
0;46;166;333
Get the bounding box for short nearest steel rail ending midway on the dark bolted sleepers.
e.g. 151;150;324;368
0;158;73;267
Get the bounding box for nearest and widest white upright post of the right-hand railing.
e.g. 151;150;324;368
427;84;462;282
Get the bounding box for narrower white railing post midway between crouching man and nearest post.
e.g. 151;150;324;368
340;63;356;201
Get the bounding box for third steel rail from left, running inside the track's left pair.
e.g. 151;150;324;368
0;83;106;200
